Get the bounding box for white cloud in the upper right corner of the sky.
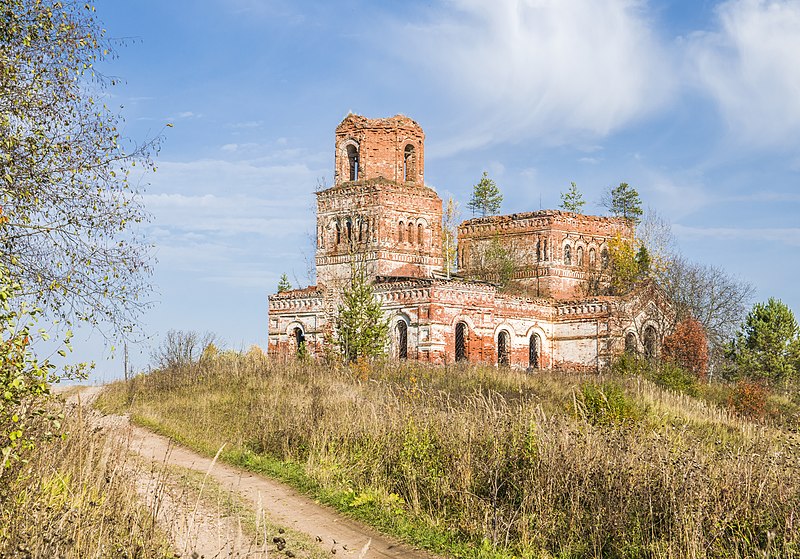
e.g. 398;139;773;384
688;0;800;147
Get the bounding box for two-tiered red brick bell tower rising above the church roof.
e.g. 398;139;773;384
316;114;443;287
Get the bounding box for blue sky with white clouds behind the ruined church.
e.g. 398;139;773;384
75;0;800;379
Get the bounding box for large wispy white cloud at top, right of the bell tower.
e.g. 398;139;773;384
398;0;673;153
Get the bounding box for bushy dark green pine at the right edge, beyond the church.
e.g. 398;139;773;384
728;297;800;384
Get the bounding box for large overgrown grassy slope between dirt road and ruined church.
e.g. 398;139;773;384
98;351;800;558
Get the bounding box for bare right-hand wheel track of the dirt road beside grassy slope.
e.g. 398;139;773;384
71;386;434;559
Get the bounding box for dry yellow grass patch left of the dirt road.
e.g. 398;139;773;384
0;396;173;559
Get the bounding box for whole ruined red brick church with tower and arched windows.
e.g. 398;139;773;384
269;114;667;370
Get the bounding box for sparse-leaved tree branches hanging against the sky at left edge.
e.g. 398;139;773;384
0;0;157;333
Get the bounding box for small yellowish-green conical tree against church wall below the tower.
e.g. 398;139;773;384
335;260;389;362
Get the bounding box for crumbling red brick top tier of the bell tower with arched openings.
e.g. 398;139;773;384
334;114;425;186
